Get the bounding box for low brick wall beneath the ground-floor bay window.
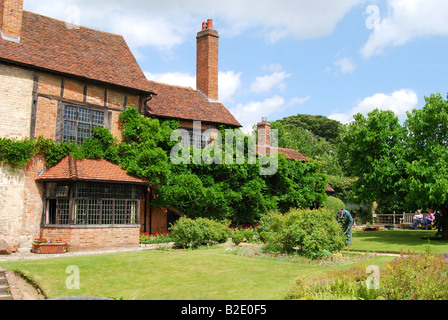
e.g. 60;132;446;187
41;226;140;251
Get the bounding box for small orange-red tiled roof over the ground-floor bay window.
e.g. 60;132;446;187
36;156;146;184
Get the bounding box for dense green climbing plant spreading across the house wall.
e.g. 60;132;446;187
0;107;326;224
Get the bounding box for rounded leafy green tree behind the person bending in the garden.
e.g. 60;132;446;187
339;109;406;203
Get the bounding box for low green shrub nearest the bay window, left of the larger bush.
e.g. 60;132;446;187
171;217;231;248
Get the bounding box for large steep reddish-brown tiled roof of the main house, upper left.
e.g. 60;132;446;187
0;11;150;92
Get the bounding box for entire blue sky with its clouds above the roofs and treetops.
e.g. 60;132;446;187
24;0;448;130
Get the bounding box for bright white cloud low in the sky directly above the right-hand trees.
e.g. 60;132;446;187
329;89;418;123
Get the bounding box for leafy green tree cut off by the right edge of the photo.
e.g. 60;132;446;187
405;94;448;240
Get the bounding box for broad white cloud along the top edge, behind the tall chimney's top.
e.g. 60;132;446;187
25;0;362;51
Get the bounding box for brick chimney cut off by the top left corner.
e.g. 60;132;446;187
0;0;23;41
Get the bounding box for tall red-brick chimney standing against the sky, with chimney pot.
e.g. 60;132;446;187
196;19;219;100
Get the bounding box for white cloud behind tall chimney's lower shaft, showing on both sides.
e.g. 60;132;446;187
145;71;242;104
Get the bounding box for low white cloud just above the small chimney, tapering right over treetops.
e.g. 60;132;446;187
229;95;310;133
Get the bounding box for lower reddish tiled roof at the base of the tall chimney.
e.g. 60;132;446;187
148;81;241;127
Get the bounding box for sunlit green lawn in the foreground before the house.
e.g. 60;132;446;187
0;247;391;300
